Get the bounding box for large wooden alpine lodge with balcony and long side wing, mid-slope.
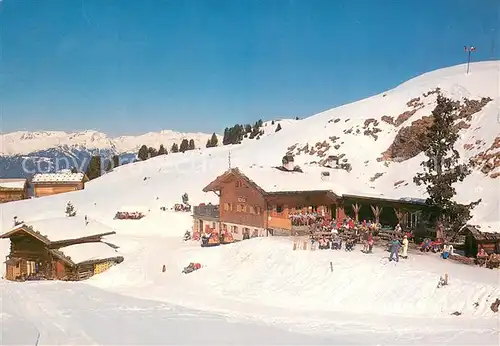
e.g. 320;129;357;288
193;165;435;240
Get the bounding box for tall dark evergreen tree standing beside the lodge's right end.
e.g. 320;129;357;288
413;95;481;237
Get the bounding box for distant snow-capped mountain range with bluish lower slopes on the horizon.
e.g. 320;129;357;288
0;130;222;178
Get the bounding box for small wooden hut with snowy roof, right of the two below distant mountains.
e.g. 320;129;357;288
31;172;89;197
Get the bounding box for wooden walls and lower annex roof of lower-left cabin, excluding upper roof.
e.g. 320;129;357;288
0;218;123;281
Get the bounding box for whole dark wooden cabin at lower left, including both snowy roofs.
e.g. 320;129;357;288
0;216;123;281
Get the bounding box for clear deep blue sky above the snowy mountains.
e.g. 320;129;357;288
0;0;500;135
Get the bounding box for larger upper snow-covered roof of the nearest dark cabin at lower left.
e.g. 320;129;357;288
0;215;115;243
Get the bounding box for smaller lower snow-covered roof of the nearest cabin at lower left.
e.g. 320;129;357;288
55;242;121;264
